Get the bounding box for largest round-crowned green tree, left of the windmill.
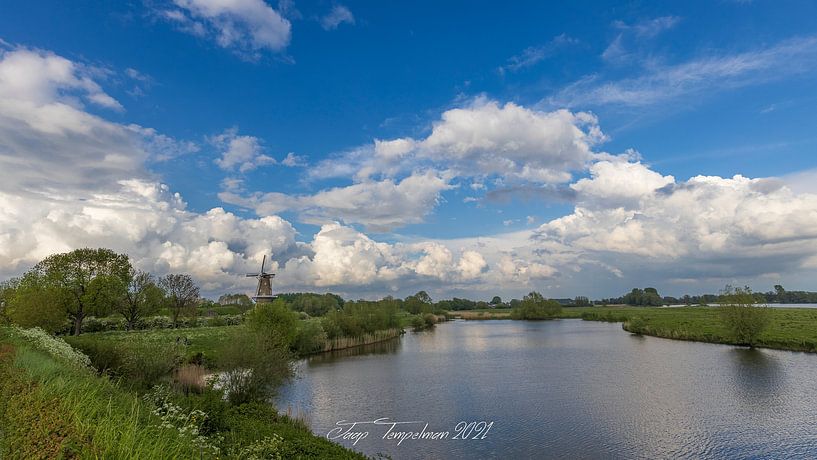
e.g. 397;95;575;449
25;248;131;335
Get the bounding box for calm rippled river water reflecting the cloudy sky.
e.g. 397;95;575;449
278;320;817;459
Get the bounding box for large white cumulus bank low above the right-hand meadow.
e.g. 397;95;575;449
534;162;817;278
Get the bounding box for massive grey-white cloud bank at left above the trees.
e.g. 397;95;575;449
0;45;299;290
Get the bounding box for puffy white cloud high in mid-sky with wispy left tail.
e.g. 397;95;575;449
312;97;605;183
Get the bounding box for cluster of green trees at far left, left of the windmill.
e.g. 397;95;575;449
0;248;201;335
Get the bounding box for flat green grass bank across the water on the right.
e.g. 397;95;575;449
449;306;817;353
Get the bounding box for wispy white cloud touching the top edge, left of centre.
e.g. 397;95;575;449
161;0;291;58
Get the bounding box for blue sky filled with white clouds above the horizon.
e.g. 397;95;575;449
0;0;817;299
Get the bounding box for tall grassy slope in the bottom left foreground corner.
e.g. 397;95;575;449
0;331;198;459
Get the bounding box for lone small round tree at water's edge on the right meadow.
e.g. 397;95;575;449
718;286;771;347
